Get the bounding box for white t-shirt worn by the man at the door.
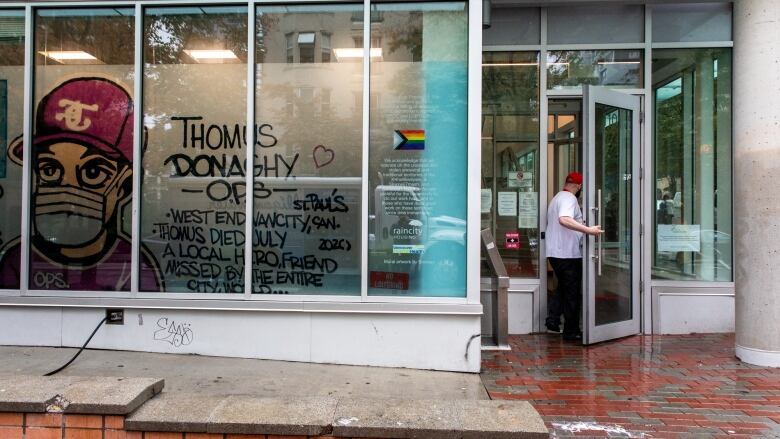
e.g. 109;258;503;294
545;191;582;259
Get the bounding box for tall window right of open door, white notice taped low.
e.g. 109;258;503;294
653;48;733;281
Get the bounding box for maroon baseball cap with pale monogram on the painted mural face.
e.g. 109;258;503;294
11;78;133;163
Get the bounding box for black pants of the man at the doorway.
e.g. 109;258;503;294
547;258;582;334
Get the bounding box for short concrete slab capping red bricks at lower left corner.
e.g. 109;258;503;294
0;375;165;415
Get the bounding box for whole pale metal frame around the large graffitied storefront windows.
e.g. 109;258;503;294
0;0;482;315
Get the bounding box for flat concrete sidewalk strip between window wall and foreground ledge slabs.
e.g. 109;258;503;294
0;346;490;400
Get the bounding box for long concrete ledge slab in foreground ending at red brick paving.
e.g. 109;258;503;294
125;394;549;439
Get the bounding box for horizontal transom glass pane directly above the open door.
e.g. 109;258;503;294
547;49;644;90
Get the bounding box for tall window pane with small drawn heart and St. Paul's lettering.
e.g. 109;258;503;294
252;4;364;296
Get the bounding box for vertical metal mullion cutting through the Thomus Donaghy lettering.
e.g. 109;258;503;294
244;0;257;299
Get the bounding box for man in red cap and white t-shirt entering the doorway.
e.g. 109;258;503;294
545;172;602;340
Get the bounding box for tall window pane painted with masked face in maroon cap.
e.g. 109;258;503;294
27;8;134;291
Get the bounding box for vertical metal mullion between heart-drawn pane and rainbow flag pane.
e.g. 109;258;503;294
360;0;371;301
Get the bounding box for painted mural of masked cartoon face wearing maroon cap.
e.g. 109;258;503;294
0;78;161;291
